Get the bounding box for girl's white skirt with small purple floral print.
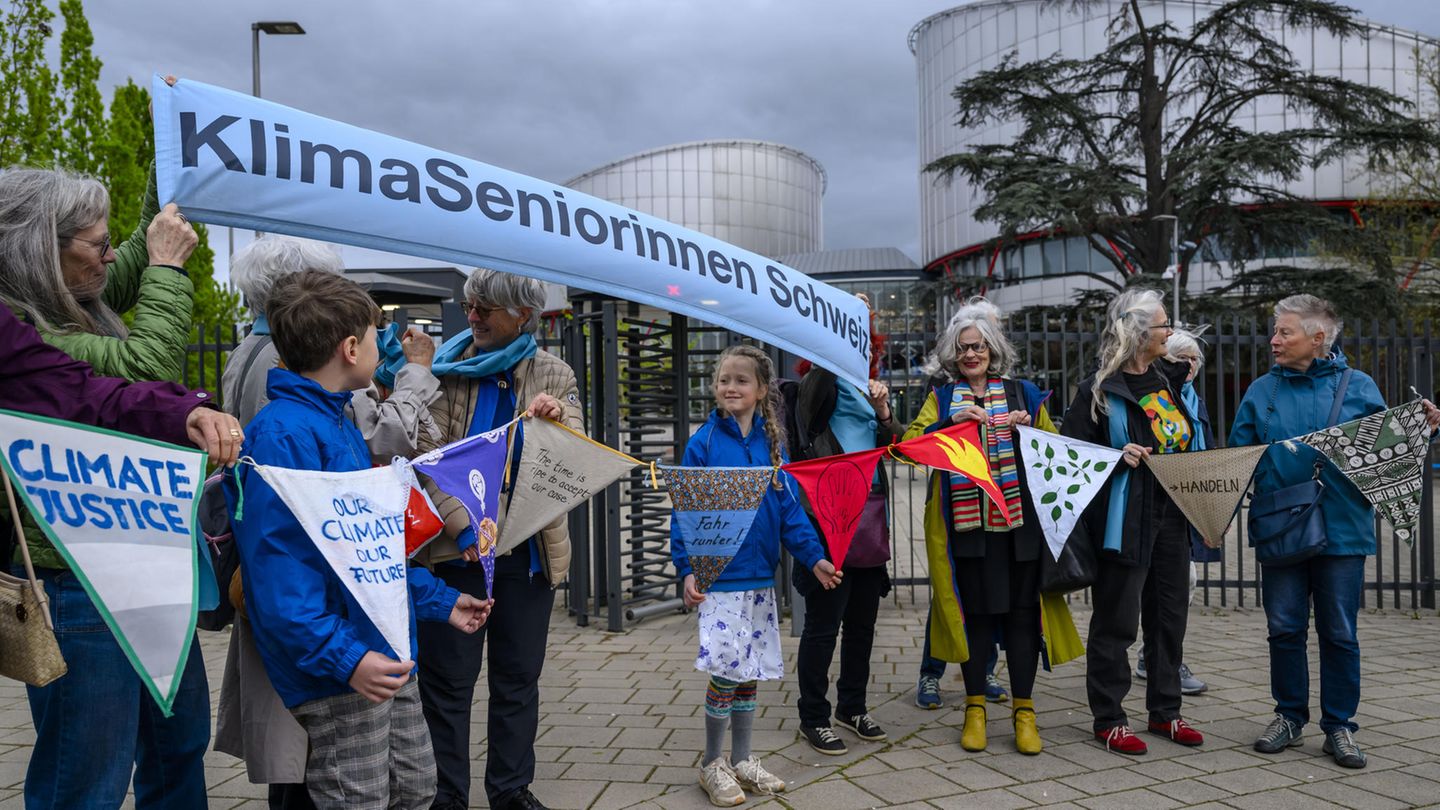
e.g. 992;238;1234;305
696;588;785;683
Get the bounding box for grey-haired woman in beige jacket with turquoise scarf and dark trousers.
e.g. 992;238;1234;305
416;268;585;810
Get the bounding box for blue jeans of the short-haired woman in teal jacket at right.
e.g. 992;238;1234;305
1260;555;1365;732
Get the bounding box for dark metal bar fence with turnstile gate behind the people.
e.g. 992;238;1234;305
186;305;1440;630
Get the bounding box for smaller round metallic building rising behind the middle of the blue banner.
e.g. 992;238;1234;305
566;141;825;257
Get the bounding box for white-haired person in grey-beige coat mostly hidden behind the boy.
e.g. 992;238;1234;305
215;235;439;810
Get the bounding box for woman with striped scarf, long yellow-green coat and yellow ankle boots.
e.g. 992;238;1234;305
904;297;1073;754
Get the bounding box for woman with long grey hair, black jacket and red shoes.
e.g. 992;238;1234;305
1061;288;1204;754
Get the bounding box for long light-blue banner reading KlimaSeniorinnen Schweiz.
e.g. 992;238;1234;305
151;75;870;388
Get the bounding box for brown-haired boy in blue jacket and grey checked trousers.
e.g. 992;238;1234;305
228;271;490;810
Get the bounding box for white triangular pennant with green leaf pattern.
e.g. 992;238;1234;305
1015;425;1120;561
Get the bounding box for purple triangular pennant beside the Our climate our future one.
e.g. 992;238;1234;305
410;425;510;595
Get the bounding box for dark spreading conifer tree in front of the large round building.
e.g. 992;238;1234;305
927;0;1434;317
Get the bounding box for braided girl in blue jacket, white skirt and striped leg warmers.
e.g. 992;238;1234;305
670;346;841;807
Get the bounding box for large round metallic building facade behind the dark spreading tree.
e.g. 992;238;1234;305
910;0;1436;273
